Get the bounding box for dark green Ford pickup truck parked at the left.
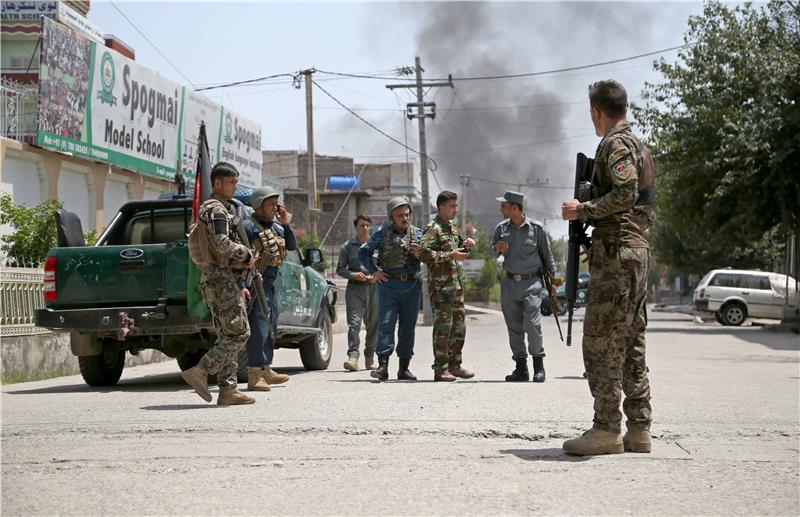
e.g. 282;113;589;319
36;196;337;386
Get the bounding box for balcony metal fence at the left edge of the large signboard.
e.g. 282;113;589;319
0;77;39;144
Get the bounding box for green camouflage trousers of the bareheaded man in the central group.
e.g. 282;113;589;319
429;285;467;370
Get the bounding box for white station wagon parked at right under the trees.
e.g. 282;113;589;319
693;268;797;326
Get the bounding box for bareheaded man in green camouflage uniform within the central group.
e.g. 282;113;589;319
419;191;475;381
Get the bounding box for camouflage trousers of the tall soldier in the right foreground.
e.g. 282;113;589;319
583;240;652;432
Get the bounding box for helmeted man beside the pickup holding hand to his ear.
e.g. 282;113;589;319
245;187;297;391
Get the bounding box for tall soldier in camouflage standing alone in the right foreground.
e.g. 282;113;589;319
561;81;655;455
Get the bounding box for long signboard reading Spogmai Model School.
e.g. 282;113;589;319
36;20;261;187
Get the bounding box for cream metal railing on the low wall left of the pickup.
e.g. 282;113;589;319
0;266;49;337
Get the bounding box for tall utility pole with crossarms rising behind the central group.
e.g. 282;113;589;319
386;56;453;325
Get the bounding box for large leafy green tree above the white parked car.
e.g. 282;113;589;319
633;2;800;273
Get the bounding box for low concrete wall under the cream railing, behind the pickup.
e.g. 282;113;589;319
0;332;172;375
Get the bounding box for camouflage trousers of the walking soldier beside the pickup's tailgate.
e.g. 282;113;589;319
199;274;250;388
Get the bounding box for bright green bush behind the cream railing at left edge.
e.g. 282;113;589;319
0;194;63;265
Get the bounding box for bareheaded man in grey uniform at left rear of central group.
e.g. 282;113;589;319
336;215;378;372
